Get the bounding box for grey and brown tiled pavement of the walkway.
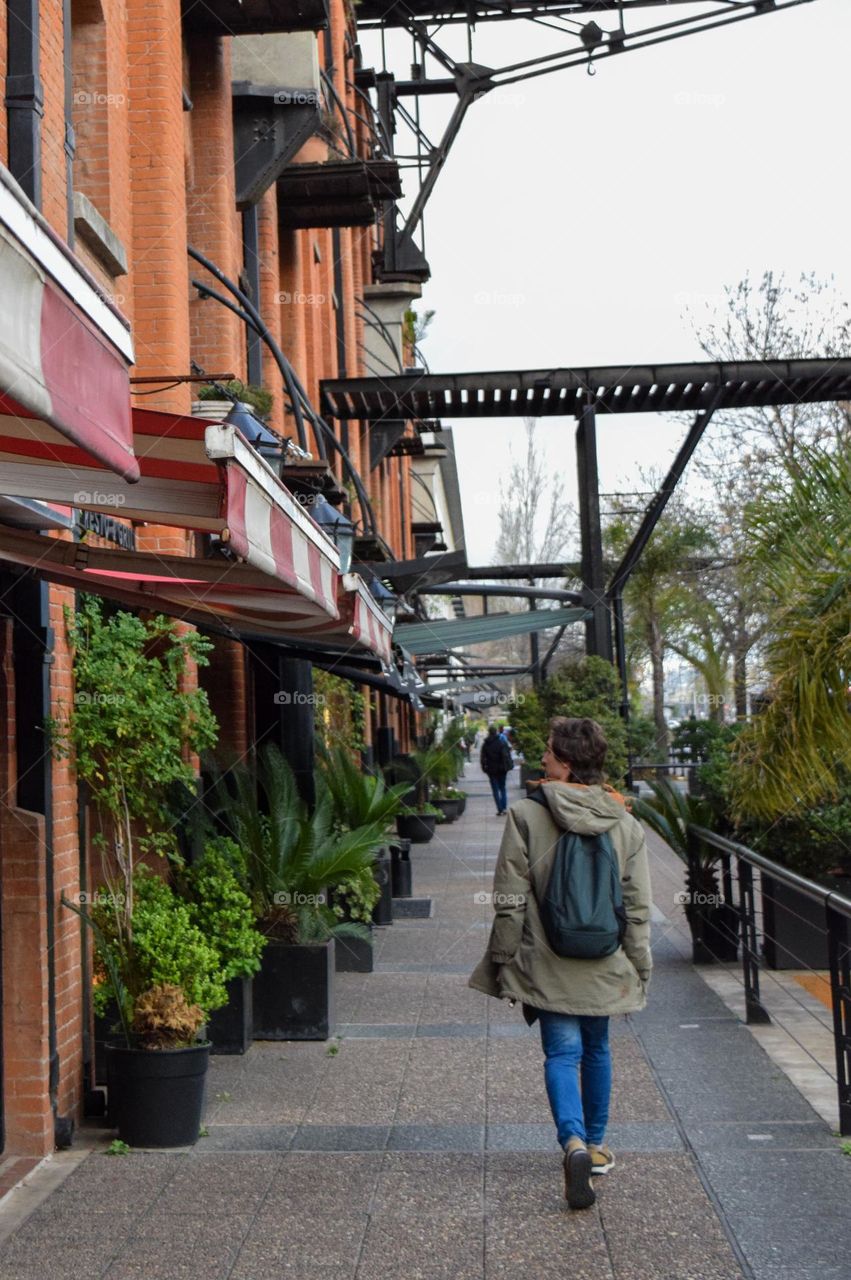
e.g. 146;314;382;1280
0;768;851;1280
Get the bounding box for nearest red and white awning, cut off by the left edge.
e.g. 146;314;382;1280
0;165;138;478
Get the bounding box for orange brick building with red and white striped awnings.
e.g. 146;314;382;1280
0;0;445;1156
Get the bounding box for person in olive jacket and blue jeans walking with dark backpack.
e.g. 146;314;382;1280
470;717;653;1208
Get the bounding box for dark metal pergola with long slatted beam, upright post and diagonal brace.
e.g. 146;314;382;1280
321;360;851;716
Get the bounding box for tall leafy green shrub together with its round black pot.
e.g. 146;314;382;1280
51;598;218;1147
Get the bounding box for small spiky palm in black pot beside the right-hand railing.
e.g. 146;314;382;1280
631;778;738;964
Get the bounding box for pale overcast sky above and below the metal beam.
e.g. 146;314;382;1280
365;0;851;563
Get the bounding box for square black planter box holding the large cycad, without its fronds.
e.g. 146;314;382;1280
253;938;335;1039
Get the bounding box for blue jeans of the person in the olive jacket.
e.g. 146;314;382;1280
539;1009;612;1147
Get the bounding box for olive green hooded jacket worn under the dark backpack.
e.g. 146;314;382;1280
468;782;653;1015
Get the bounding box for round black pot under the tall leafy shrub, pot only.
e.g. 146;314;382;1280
106;1044;210;1147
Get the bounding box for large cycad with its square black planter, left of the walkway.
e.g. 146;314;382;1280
211;745;384;1039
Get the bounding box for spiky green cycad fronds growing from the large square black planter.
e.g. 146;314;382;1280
211;745;384;942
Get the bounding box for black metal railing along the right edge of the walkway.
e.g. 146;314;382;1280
688;827;851;1137
